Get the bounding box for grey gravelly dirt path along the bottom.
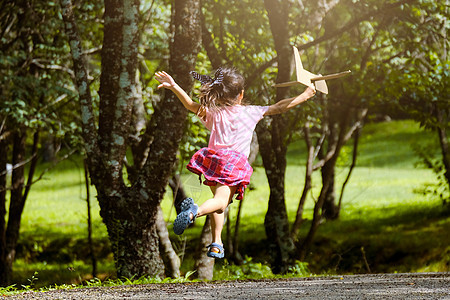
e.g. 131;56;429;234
7;273;450;300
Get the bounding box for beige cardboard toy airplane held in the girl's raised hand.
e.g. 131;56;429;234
274;46;351;94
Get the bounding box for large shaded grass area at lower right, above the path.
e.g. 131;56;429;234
300;205;450;274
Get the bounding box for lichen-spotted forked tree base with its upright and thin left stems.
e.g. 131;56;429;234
61;0;164;278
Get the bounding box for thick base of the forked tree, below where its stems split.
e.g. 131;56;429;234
97;187;164;278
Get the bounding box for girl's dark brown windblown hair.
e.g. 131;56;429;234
199;68;245;109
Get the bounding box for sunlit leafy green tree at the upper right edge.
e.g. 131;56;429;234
385;0;450;203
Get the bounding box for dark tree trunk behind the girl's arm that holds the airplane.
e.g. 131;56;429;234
257;0;339;272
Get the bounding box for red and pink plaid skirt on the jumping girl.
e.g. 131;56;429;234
186;148;253;200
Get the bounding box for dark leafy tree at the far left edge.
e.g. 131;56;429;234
0;1;77;285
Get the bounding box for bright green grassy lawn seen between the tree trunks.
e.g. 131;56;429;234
9;121;450;285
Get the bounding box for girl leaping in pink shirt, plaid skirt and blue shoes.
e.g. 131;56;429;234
155;68;316;258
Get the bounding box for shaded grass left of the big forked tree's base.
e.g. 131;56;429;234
13;228;115;288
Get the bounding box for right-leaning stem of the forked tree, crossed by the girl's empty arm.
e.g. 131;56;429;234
138;0;200;276
